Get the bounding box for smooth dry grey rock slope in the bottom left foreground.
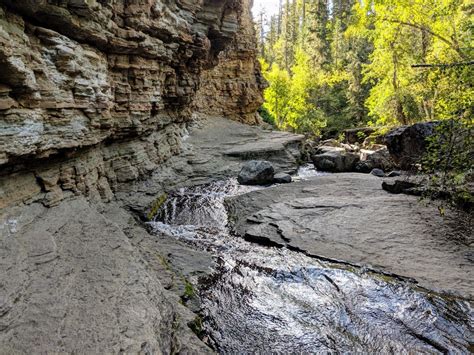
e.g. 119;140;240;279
0;198;209;353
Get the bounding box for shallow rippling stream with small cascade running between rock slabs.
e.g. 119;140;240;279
150;172;473;353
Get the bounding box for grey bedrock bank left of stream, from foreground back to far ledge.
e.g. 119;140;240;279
0;114;304;354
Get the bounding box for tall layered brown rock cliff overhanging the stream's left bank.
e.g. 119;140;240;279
0;0;263;208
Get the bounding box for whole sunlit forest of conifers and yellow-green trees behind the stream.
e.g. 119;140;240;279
257;0;474;135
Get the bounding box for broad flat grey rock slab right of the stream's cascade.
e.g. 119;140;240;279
226;174;474;298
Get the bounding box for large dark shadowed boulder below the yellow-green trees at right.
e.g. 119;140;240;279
385;122;439;170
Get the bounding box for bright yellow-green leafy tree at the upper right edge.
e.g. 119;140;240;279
350;0;473;124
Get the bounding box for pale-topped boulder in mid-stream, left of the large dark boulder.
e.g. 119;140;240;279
311;146;360;173
